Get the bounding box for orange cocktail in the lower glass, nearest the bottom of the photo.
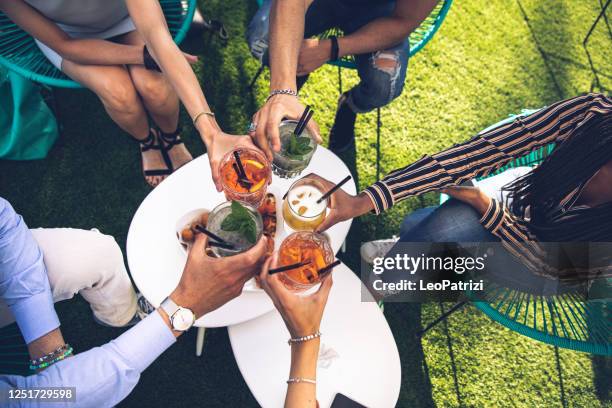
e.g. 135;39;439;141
278;231;334;291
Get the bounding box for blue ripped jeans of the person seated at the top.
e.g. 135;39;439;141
247;0;410;113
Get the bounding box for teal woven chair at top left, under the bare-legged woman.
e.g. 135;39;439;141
0;0;196;88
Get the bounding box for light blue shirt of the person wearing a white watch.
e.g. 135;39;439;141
0;198;176;408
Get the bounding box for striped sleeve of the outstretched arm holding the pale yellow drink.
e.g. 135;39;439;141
366;94;612;213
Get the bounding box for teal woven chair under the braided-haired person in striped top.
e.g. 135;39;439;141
420;110;612;356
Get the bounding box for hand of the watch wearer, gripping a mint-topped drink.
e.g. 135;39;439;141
170;234;267;318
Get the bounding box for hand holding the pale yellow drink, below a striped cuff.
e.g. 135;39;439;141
294;174;374;232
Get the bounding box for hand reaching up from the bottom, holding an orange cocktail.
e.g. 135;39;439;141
259;254;332;338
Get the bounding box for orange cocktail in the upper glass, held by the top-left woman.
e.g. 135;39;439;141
219;147;272;208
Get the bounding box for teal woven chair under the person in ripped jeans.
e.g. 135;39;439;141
251;0;453;180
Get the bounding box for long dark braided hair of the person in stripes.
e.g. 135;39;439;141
504;114;612;242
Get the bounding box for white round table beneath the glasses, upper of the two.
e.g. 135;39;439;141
127;146;356;328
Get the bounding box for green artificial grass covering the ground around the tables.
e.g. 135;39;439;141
0;0;612;407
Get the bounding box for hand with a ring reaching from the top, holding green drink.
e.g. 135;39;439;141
250;95;321;161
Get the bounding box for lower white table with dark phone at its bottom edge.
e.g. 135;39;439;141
228;264;401;408
